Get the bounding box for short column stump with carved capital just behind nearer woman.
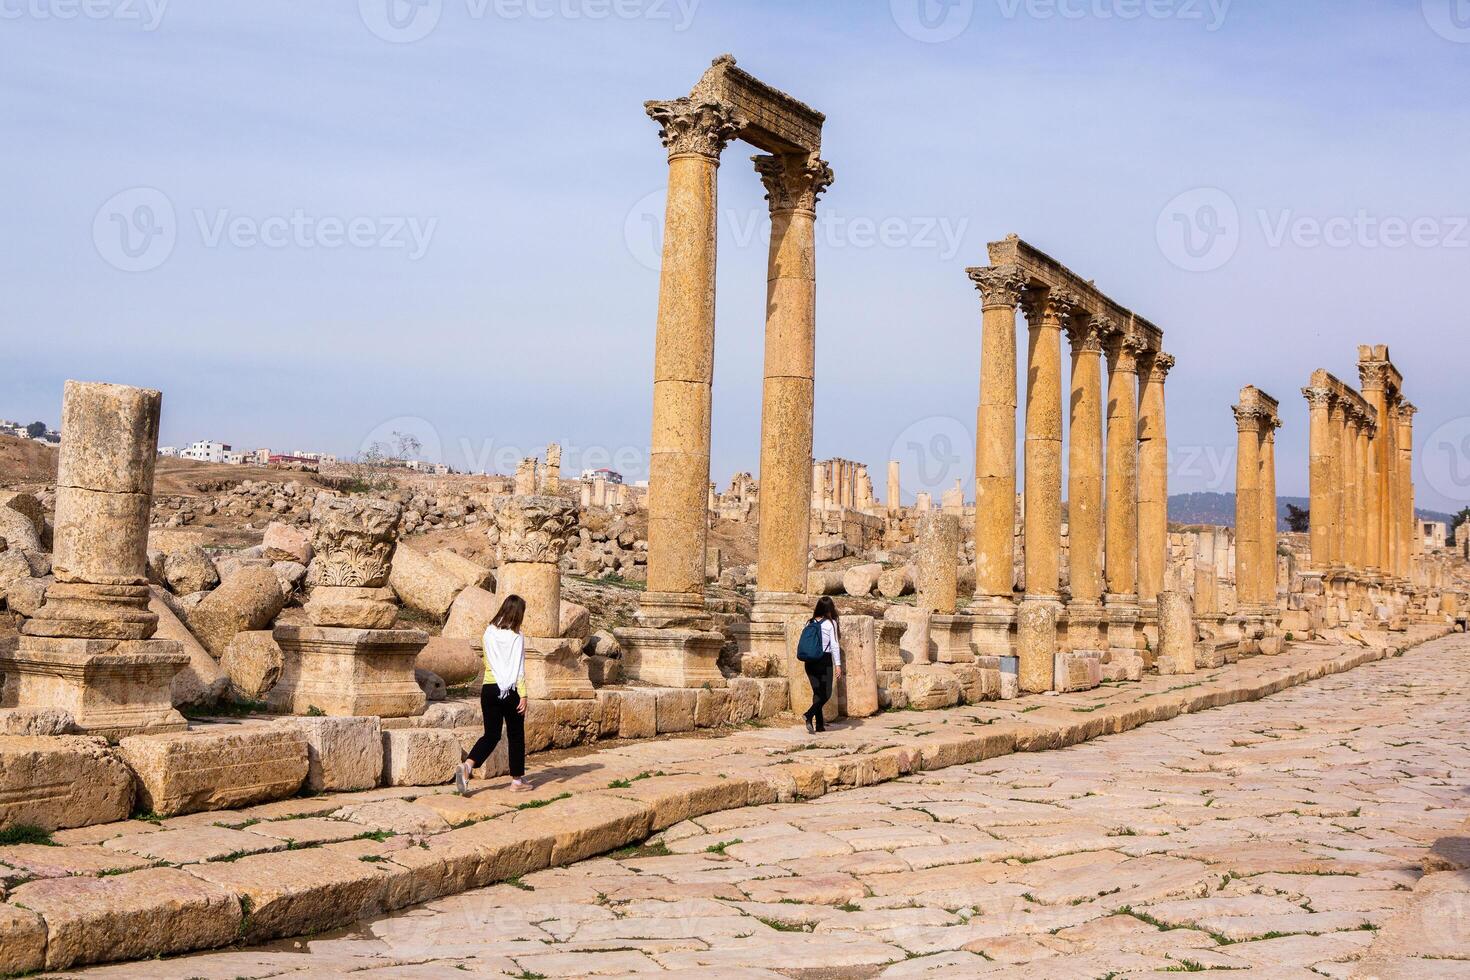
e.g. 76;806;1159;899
495;495;597;701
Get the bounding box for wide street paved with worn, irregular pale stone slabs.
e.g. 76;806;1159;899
63;636;1470;980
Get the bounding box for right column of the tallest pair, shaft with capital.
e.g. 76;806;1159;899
752;154;834;602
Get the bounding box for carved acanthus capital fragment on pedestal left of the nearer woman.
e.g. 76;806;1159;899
306;492;403;589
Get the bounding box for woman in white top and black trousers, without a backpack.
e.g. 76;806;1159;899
454;595;531;796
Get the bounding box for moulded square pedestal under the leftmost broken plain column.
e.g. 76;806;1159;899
0;631;188;741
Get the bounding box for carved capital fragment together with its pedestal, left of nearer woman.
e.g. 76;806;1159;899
266;502;429;718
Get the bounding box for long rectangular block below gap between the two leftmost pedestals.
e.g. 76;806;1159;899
118;724;309;817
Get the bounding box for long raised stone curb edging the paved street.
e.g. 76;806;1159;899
0;627;1449;974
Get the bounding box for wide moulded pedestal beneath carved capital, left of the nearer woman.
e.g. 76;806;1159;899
266;626;429;718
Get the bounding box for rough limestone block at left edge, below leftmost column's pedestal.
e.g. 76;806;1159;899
0;735;132;830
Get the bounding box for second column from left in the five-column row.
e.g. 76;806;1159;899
1025;289;1076;602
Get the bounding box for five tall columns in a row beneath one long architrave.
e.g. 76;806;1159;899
970;266;1175;649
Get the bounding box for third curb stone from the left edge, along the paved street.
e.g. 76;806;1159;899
190;848;388;942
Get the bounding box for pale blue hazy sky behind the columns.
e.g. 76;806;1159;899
0;0;1470;508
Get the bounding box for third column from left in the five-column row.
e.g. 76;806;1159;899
1067;317;1108;649
